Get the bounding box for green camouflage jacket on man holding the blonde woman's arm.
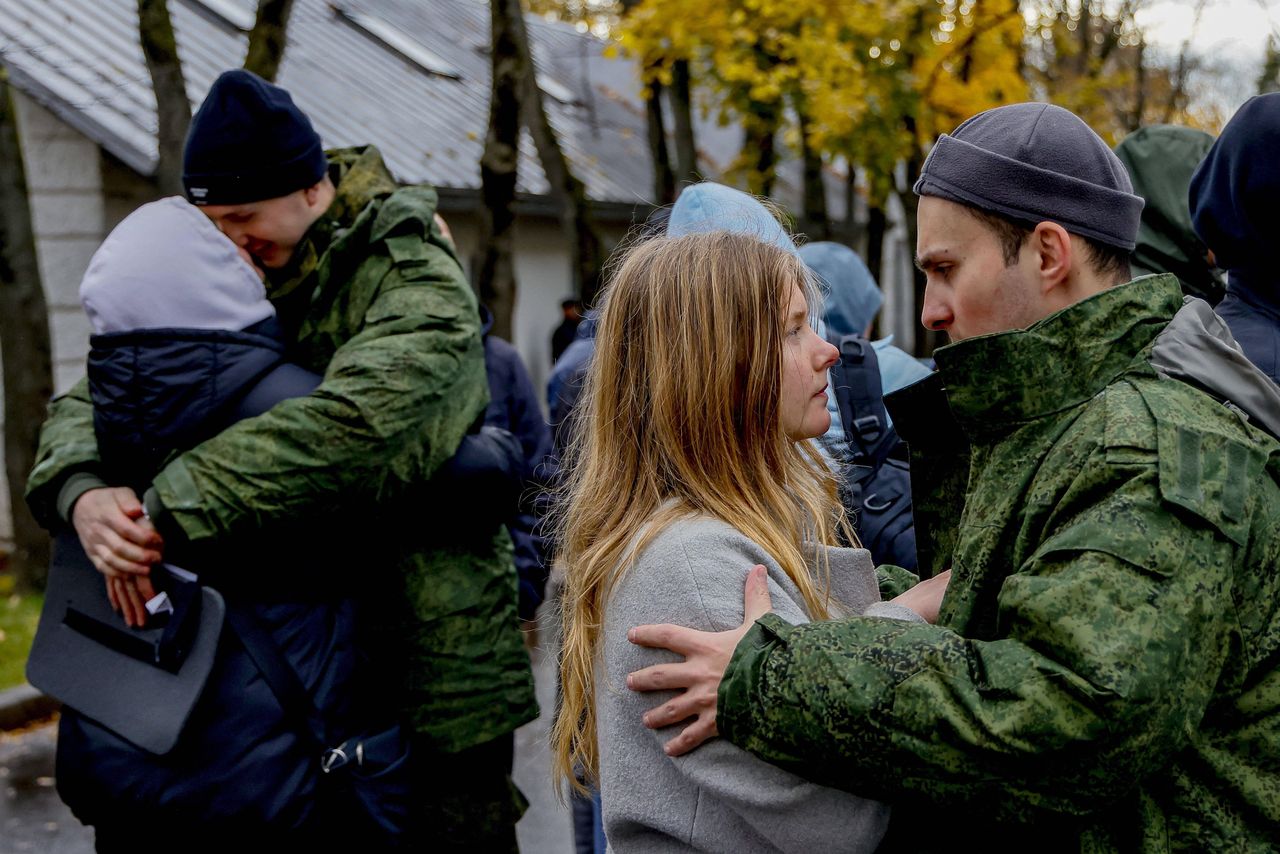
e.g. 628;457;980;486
719;275;1280;851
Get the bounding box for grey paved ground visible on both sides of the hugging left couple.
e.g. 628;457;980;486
0;622;573;854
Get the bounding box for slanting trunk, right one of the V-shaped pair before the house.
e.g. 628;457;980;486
509;0;604;305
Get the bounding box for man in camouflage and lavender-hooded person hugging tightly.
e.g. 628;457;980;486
28;70;536;851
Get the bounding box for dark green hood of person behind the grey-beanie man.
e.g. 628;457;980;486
1116;124;1224;305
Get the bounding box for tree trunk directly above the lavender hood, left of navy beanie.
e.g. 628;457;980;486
138;0;191;196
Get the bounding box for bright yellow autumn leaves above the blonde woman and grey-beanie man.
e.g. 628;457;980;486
617;0;1027;201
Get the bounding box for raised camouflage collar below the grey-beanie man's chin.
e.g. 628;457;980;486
934;274;1183;435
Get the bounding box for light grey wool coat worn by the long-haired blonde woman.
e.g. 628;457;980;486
595;517;919;854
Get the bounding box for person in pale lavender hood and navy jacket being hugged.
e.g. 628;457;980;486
65;196;378;851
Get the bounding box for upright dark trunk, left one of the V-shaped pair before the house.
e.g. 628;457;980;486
474;0;529;341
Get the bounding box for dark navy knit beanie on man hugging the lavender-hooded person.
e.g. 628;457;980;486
182;69;328;205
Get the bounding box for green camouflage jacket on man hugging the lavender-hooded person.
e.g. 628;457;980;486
28;146;536;752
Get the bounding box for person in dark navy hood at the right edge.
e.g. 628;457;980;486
1190;93;1280;382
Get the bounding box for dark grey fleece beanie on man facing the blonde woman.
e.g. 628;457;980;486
914;104;1143;251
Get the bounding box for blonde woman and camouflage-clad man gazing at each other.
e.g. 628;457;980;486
554;104;1280;854
